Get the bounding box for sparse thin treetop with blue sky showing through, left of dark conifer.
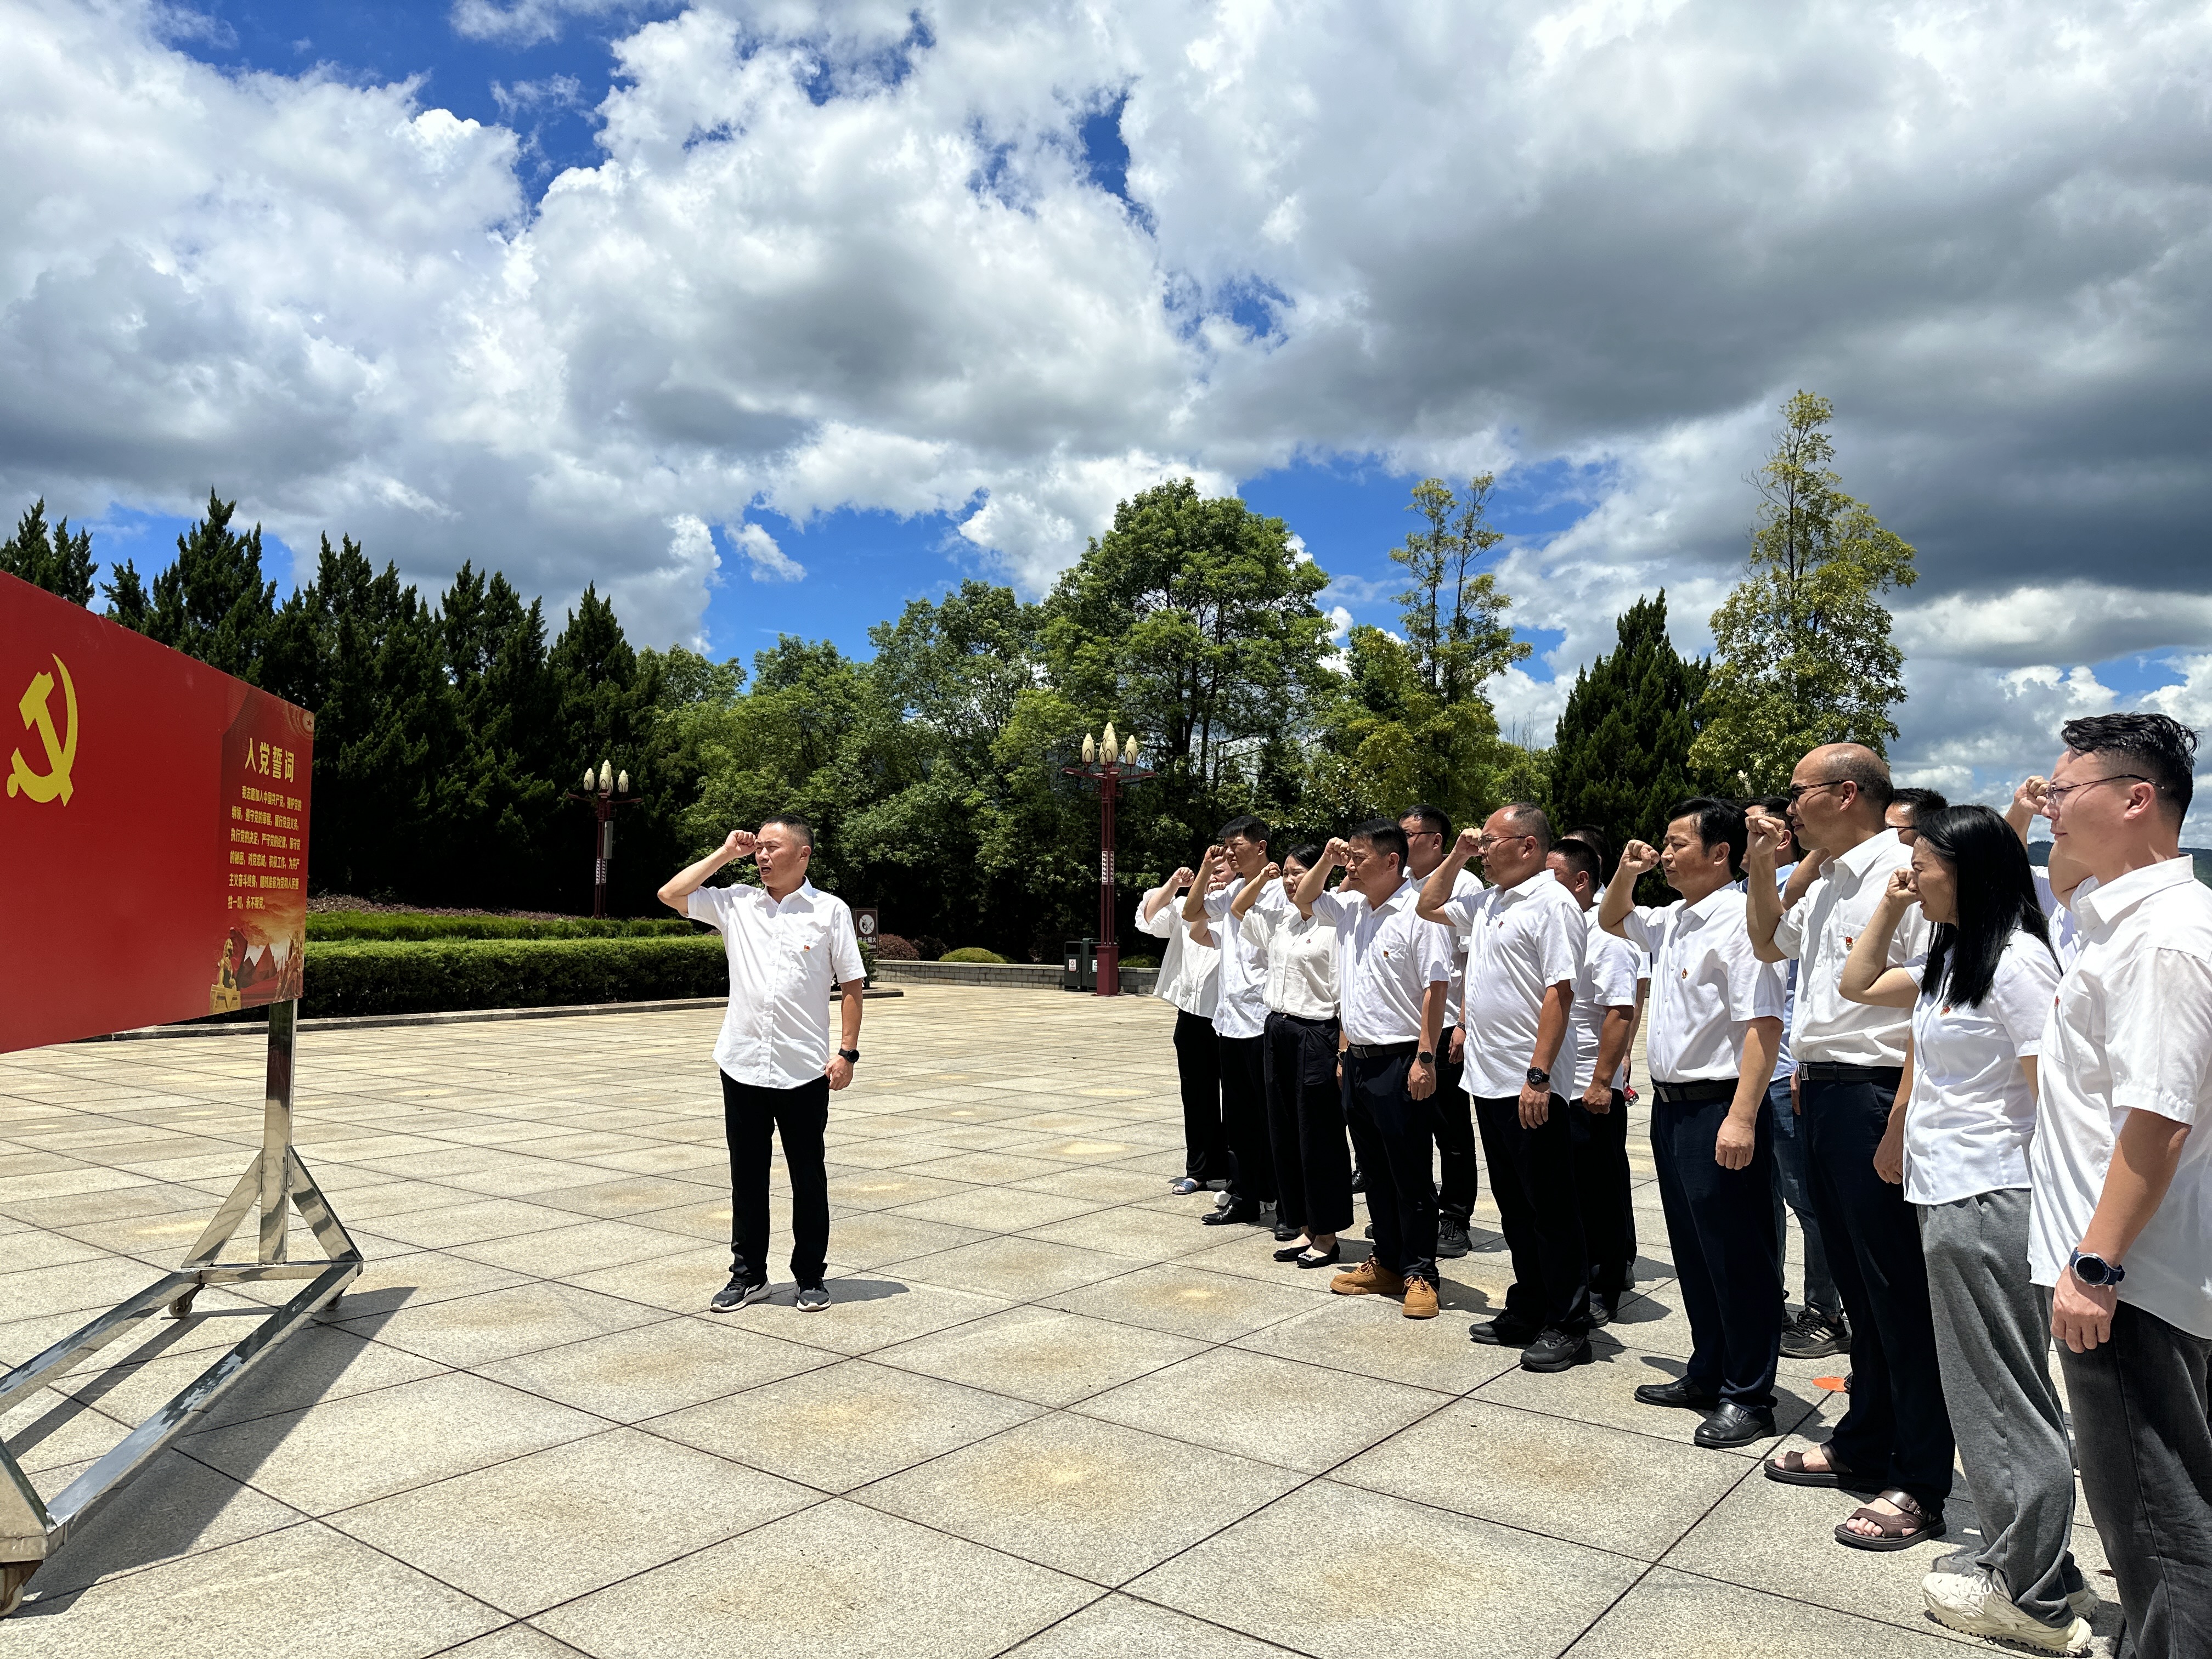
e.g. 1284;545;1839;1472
1391;473;1533;706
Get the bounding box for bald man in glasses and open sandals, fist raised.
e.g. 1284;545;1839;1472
1743;743;1953;1548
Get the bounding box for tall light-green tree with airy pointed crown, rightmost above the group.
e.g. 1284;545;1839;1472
1692;392;1918;794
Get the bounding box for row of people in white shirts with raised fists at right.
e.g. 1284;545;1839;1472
1139;714;2212;1655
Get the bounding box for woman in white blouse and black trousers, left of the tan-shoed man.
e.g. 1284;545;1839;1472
1230;847;1352;1267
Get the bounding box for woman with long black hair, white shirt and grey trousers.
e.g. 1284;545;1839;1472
1838;808;2090;1652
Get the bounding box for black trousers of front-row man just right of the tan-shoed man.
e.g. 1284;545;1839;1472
1475;1095;1590;1336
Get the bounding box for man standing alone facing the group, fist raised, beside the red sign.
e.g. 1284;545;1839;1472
662;814;865;1314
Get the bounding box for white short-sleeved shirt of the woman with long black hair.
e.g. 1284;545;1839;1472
1905;934;2059;1203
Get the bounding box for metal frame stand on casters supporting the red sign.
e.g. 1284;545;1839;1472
0;1002;363;1617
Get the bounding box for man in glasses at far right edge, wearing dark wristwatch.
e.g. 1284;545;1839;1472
2028;714;2212;1659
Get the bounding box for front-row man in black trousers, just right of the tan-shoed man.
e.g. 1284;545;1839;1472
1420;801;1590;1372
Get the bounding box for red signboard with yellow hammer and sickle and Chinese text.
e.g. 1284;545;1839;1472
0;575;314;1053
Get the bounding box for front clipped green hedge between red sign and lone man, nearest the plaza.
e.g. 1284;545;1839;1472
301;934;730;1018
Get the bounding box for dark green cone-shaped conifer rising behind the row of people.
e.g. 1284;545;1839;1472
1550;589;1712;874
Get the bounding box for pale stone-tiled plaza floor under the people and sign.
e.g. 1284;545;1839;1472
0;989;2115;1659
